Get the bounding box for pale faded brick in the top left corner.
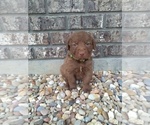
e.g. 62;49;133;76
0;0;28;13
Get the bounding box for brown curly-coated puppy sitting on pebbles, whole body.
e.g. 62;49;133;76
60;31;95;92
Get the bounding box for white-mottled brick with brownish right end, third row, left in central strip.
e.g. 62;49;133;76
28;33;50;45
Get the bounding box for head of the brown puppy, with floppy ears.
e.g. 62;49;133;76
67;31;96;60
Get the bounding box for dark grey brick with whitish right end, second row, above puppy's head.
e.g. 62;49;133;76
82;14;103;29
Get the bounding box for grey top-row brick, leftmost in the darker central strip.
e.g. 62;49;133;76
28;0;45;13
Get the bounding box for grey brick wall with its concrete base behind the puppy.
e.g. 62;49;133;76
0;0;150;73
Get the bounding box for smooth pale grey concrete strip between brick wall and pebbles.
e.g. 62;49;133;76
0;58;150;74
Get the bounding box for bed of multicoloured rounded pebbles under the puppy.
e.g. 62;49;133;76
0;71;150;125
